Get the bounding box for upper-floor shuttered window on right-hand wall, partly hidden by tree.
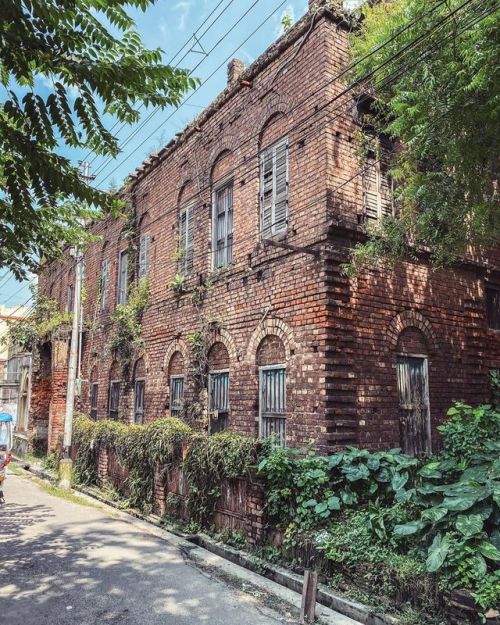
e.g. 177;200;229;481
363;141;394;223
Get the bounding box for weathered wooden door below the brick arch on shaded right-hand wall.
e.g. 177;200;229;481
397;356;431;456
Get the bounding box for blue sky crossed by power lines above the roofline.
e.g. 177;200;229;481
0;0;362;306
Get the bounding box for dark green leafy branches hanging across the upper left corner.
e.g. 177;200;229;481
0;0;196;277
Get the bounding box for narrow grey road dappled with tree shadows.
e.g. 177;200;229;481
0;474;290;625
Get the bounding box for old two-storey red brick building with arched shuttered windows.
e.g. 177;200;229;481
31;7;500;452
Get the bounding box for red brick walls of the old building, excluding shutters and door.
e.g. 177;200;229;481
36;4;500;449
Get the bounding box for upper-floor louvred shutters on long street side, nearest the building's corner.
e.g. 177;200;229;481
260;138;288;239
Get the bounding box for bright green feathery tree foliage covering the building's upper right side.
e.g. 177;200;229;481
351;0;500;269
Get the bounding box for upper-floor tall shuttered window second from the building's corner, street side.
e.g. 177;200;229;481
212;180;233;268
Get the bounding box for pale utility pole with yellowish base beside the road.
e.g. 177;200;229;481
59;161;95;490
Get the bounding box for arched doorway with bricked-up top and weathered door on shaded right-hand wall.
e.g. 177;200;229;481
396;326;431;456
